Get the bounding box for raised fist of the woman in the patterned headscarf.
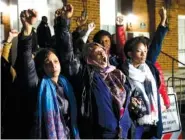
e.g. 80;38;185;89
55;4;74;19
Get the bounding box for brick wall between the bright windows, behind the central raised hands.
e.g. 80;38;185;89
68;0;100;40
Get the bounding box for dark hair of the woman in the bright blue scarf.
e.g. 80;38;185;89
34;48;56;78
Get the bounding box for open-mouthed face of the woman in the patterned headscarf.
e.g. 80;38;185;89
90;46;108;68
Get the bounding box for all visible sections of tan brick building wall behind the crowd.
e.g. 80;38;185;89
4;0;185;70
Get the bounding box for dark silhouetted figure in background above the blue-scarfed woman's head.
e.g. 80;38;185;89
37;16;51;48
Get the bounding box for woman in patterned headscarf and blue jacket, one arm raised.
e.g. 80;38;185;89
54;4;131;139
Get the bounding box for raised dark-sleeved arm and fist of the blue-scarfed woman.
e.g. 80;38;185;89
15;9;38;89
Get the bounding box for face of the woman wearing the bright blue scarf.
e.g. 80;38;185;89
44;52;61;78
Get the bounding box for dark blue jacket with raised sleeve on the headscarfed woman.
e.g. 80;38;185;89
55;17;131;139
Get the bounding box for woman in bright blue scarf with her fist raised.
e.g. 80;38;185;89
13;9;79;139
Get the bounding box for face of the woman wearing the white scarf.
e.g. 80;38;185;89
129;43;148;67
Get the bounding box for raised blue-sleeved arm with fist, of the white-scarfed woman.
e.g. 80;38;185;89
147;7;168;63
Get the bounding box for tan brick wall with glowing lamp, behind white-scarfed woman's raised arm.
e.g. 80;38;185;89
129;0;185;70
